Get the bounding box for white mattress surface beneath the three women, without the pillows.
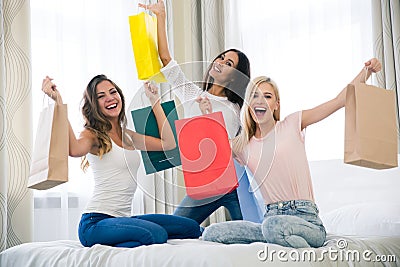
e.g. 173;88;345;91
0;236;400;267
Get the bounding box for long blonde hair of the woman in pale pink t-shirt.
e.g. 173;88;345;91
232;76;281;155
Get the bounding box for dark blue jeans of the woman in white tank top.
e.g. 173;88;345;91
78;213;201;248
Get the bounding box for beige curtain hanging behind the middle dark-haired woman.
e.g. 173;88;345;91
169;0;229;226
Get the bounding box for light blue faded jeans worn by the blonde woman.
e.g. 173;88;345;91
203;200;326;248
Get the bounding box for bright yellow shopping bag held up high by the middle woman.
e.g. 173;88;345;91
129;12;166;83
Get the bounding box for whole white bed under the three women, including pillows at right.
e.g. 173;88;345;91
0;160;400;267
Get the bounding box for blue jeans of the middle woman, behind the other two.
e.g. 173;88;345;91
174;190;243;224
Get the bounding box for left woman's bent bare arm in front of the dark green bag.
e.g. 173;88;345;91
130;83;176;151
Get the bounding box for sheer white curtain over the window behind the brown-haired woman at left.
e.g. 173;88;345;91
30;0;142;241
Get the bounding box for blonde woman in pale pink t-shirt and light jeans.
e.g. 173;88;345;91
203;58;381;248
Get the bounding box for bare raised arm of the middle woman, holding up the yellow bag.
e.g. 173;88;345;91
139;0;171;66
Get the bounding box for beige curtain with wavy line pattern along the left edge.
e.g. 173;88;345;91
0;0;33;251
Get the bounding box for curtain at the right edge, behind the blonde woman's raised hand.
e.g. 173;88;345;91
372;0;400;151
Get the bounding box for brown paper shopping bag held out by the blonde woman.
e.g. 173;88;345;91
344;83;398;169
